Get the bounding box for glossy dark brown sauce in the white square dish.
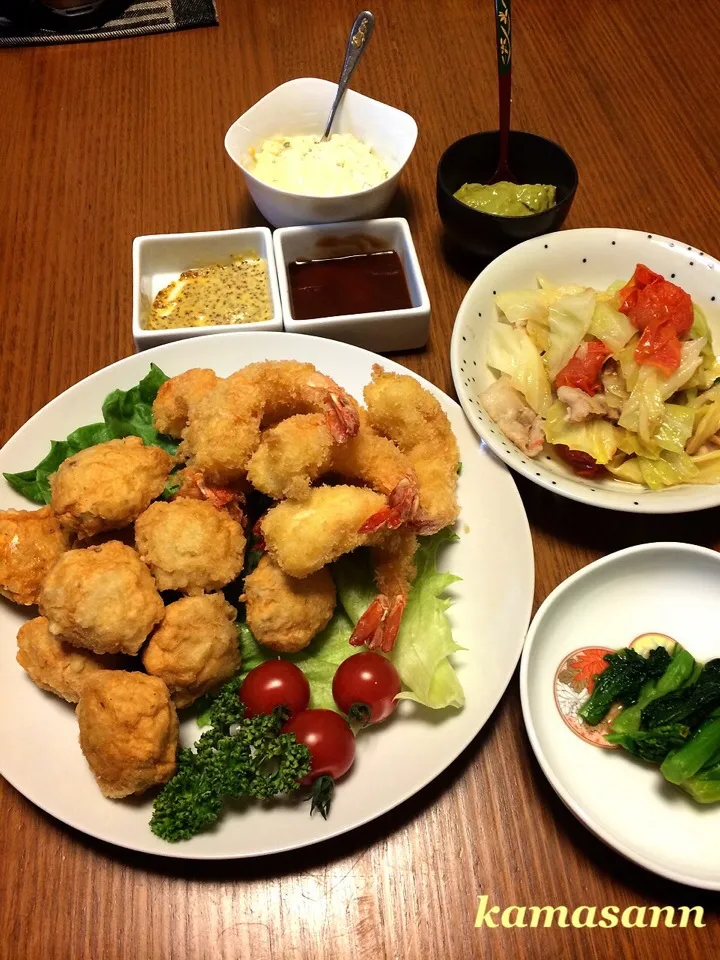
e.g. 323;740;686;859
288;250;412;320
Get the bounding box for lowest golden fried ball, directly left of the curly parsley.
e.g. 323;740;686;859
77;670;178;799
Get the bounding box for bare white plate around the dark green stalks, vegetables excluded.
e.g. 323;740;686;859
520;543;720;890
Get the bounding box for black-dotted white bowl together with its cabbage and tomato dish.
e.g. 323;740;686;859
451;228;720;513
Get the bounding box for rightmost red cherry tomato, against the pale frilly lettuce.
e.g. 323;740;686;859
333;651;400;726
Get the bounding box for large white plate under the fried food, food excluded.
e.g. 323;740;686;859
0;333;533;859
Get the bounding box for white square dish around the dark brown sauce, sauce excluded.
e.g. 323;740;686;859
273;217;430;353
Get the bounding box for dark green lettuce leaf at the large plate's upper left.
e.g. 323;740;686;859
3;363;178;503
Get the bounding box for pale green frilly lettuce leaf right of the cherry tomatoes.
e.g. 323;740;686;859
333;527;465;710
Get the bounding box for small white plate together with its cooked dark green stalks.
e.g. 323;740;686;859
520;543;720;890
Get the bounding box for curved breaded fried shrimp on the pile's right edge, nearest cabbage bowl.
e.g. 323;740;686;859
364;364;460;534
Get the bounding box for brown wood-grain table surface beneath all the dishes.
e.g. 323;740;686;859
0;0;720;960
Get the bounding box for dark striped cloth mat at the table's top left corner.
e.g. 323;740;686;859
0;0;218;47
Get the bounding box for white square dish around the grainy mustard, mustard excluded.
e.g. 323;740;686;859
133;227;283;350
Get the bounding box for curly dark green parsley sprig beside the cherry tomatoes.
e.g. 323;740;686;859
150;680;310;843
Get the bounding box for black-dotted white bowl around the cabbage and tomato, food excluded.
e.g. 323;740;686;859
450;227;720;513
